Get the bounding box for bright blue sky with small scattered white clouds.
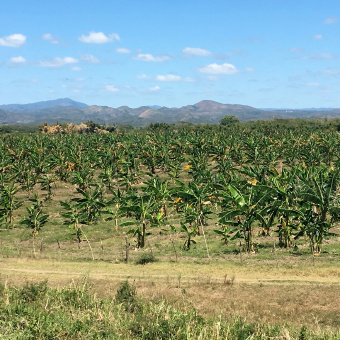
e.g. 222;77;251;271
0;0;340;108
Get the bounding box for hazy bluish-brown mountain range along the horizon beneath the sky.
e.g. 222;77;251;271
0;98;340;126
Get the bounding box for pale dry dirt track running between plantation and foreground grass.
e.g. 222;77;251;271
0;259;340;285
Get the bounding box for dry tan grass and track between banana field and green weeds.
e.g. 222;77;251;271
0;259;340;329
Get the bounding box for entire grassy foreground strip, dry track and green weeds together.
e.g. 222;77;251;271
0;258;340;339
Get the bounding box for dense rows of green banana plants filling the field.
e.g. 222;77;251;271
0;125;340;257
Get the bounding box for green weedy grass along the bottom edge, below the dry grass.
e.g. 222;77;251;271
0;277;340;339
